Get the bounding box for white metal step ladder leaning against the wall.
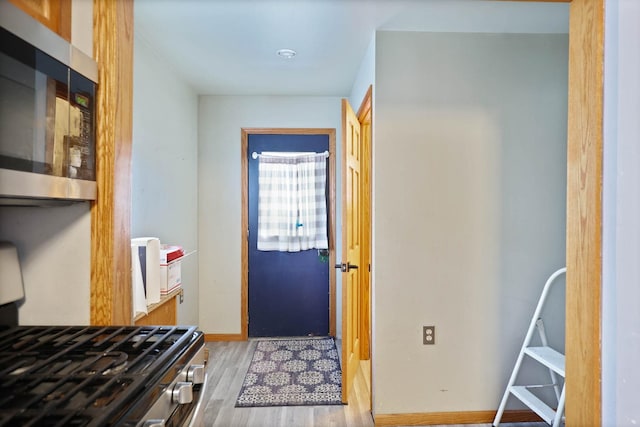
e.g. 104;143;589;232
493;268;567;427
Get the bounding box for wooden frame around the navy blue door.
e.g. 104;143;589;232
240;128;336;340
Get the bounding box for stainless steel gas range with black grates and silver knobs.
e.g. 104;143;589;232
0;326;207;427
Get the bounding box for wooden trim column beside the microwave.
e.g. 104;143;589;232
91;0;133;325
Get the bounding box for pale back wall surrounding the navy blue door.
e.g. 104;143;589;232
198;96;341;334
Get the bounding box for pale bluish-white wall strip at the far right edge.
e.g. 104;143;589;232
602;0;640;427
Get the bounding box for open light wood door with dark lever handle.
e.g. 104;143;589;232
342;99;364;403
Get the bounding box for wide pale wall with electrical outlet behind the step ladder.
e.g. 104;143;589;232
373;32;568;414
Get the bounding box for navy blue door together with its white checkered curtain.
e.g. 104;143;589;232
247;134;333;338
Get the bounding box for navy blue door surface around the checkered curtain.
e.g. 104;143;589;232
246;134;333;337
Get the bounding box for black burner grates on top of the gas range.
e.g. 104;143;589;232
0;326;203;426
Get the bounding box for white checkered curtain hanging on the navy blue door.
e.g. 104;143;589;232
258;153;329;252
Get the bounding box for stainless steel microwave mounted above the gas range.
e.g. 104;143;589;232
0;2;98;204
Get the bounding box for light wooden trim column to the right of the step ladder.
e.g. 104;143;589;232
565;0;604;427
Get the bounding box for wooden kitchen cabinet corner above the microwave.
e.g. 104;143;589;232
9;0;71;42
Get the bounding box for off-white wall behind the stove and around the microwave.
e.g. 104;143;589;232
0;0;93;325
